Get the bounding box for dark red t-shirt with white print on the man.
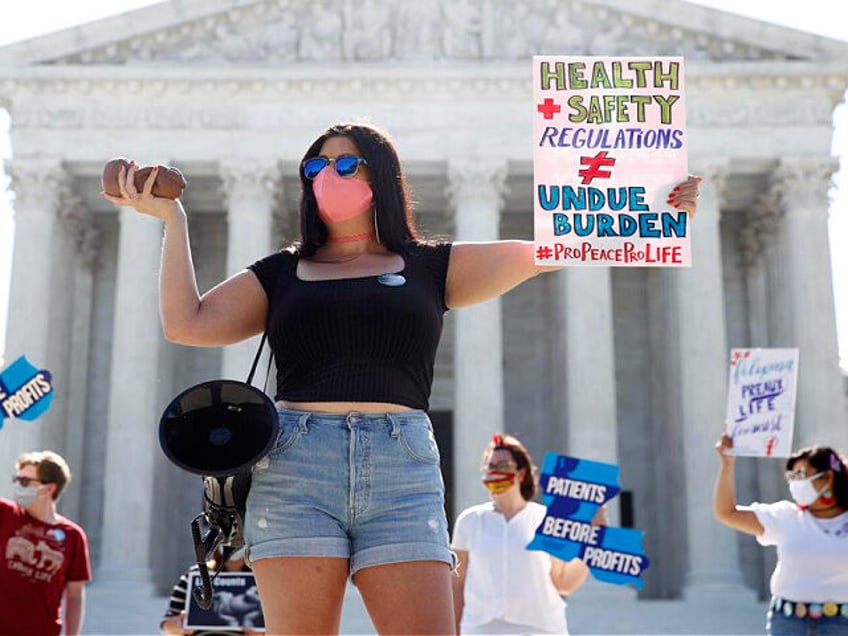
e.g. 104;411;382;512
0;498;91;634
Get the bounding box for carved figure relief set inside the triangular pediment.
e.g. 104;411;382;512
53;0;785;65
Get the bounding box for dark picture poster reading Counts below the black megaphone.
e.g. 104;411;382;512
185;572;265;632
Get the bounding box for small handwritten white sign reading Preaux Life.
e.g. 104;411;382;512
725;349;798;457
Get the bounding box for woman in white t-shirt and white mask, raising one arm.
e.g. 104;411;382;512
713;435;848;636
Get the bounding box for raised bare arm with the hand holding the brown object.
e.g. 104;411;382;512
102;163;268;347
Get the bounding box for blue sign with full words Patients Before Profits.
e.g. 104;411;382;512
527;453;650;589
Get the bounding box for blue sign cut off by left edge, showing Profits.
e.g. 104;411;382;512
0;356;53;428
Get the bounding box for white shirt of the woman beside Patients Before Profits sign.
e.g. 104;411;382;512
453;501;568;634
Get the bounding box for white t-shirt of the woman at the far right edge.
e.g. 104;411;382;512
750;501;848;603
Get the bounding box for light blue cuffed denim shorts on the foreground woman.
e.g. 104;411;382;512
245;408;454;576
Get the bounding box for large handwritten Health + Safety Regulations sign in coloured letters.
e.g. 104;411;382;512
533;56;691;267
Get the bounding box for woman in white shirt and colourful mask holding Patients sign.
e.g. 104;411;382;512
452;434;606;634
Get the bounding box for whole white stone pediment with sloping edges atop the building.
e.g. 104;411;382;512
0;0;848;66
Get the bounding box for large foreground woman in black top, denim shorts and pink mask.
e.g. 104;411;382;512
104;124;700;634
